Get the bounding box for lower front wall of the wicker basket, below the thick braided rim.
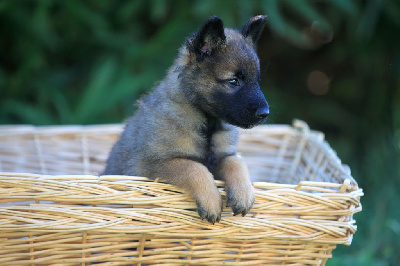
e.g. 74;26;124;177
0;230;335;265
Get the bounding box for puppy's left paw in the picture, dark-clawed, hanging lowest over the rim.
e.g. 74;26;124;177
196;190;223;224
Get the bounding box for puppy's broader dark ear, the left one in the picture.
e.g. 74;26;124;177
187;16;226;61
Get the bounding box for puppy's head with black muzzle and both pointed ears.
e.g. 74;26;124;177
180;16;269;128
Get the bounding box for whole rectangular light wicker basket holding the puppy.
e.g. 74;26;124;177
0;121;363;265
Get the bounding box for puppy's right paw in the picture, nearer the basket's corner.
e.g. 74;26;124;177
226;182;255;216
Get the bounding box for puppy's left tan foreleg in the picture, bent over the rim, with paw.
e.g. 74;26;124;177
156;159;223;224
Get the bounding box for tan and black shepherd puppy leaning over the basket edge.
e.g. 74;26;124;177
104;16;269;224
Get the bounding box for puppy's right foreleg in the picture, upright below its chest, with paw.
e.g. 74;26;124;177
216;155;254;216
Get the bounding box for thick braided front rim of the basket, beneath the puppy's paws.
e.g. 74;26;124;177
0;173;363;245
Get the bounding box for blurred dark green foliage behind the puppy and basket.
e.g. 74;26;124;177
0;0;400;265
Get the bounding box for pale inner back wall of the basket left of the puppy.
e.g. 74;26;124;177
0;126;122;175
